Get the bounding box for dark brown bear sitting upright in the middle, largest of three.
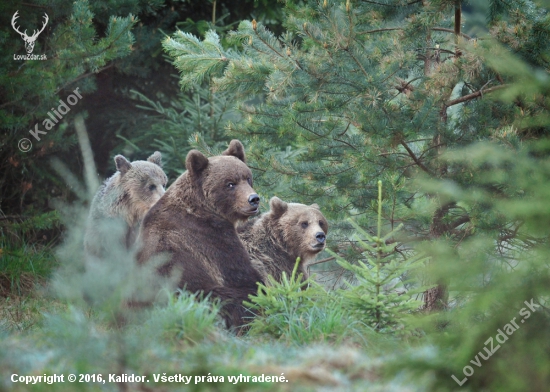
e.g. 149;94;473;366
138;140;262;328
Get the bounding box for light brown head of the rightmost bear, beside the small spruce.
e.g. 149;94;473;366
269;197;328;261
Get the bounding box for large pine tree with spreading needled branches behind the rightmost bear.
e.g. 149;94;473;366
164;0;550;310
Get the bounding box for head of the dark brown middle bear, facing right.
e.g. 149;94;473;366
185;140;260;224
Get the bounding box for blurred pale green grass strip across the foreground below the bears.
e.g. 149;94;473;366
0;270;417;391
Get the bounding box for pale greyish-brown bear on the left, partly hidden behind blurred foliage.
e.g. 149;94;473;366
84;151;167;258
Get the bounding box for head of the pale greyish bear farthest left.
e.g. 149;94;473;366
115;151;168;224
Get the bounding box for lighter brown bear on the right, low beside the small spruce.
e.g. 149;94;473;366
238;197;328;282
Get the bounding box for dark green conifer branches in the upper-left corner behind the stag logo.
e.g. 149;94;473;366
0;0;137;214
